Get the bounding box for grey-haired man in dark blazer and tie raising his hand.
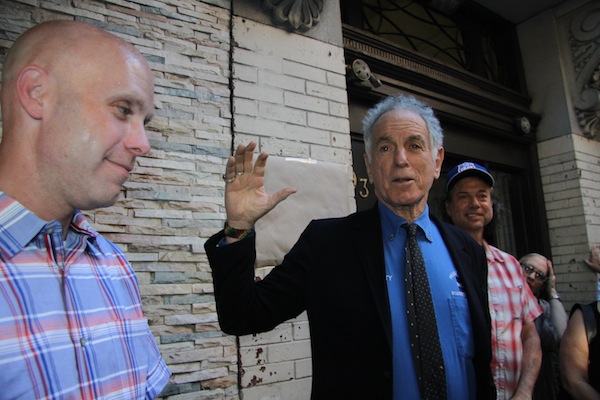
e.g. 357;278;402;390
205;95;495;399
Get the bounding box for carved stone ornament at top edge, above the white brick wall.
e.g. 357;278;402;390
264;0;323;32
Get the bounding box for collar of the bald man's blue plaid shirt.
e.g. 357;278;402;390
0;191;98;258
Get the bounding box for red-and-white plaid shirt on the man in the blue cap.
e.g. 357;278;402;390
484;243;542;400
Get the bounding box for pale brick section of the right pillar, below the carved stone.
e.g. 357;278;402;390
538;134;600;309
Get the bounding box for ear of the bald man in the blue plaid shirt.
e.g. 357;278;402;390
17;66;48;119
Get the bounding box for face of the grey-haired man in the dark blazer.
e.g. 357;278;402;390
365;110;444;219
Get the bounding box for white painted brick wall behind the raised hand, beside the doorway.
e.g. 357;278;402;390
233;17;353;400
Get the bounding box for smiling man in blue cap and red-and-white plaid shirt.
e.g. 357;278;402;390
445;162;542;400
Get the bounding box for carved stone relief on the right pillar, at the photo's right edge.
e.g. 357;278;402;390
570;5;600;137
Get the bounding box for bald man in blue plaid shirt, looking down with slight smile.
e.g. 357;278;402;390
0;21;170;399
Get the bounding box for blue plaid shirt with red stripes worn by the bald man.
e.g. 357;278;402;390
0;192;170;400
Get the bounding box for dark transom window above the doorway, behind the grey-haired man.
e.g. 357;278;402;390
341;0;521;90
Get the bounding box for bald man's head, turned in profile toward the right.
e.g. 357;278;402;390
0;21;154;225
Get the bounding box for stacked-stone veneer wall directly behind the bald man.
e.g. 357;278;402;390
0;0;238;400
